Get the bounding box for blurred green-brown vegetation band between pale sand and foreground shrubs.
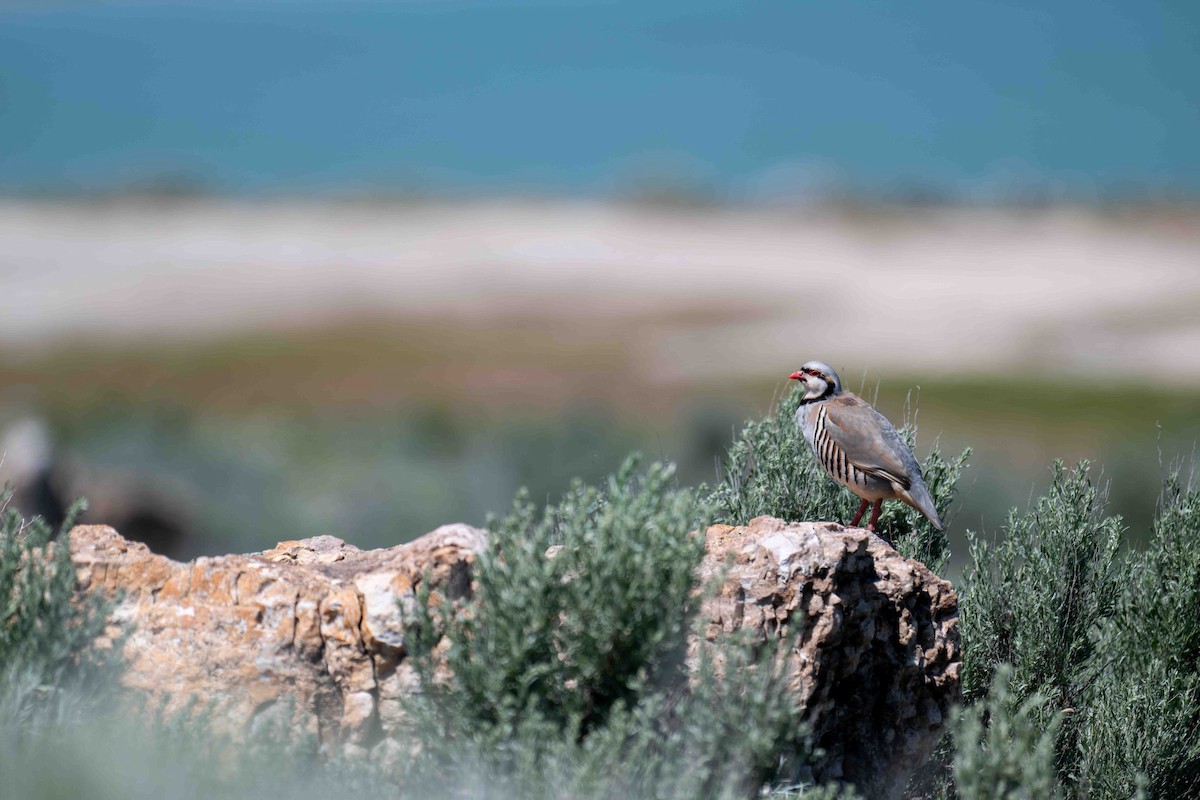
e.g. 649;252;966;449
0;321;1200;563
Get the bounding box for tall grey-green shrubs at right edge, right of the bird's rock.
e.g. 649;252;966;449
955;463;1200;800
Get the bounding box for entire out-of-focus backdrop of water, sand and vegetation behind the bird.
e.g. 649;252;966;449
0;0;1200;557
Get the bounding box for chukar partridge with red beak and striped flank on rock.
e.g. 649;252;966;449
790;361;942;530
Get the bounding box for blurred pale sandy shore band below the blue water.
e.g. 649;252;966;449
0;201;1200;384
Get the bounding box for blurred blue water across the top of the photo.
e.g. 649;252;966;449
0;0;1200;194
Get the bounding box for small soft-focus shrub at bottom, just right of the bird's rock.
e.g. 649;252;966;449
954;666;1062;800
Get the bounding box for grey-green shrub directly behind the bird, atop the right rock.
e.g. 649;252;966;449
712;387;971;572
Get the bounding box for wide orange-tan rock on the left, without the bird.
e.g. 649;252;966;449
71;525;487;748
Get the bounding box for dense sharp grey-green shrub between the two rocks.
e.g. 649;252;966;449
419;458;704;741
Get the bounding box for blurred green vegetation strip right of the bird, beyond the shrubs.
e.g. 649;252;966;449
878;375;1200;553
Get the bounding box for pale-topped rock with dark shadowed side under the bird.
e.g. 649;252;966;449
701;517;960;798
